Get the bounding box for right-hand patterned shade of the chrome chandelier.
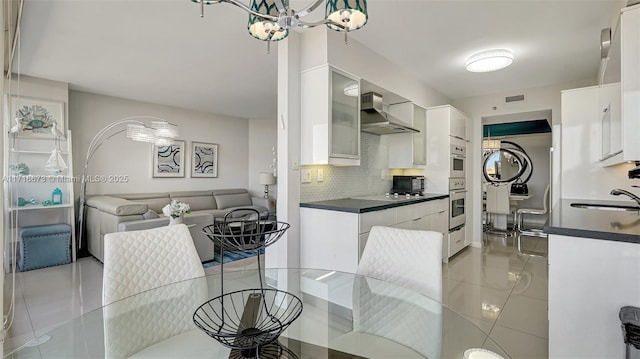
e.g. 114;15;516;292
325;0;369;31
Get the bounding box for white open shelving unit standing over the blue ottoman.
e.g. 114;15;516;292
3;131;76;270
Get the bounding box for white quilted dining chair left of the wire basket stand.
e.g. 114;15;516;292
102;224;212;358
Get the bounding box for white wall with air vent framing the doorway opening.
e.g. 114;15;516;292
452;78;596;247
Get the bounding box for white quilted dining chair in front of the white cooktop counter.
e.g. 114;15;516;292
330;226;442;358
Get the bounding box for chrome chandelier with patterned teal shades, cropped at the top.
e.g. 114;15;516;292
191;0;368;46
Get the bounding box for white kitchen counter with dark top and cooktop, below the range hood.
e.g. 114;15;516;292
300;194;452;273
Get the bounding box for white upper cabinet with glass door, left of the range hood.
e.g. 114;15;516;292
300;65;360;166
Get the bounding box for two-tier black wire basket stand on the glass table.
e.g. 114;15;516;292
193;209;302;359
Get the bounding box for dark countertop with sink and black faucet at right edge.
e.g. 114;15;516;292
544;199;640;244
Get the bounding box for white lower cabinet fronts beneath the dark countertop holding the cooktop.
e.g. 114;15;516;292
300;199;449;273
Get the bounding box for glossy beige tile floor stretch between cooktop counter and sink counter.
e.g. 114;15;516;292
443;235;549;359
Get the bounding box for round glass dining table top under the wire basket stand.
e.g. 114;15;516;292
7;269;509;359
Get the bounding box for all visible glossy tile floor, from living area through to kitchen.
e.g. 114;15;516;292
4;235;548;359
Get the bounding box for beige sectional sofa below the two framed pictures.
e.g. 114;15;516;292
86;188;269;262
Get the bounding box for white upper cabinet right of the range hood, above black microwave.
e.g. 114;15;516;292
388;102;427;168
